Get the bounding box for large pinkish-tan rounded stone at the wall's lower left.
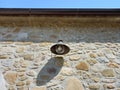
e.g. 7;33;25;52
5;71;17;85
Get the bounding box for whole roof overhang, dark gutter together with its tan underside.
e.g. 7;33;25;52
0;8;120;28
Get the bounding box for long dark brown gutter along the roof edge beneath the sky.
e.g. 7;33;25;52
0;8;120;16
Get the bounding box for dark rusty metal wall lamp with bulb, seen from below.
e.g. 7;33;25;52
50;40;70;55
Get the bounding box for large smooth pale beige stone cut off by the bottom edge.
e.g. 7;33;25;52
65;77;84;90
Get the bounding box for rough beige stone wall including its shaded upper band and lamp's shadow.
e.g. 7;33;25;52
0;26;120;90
